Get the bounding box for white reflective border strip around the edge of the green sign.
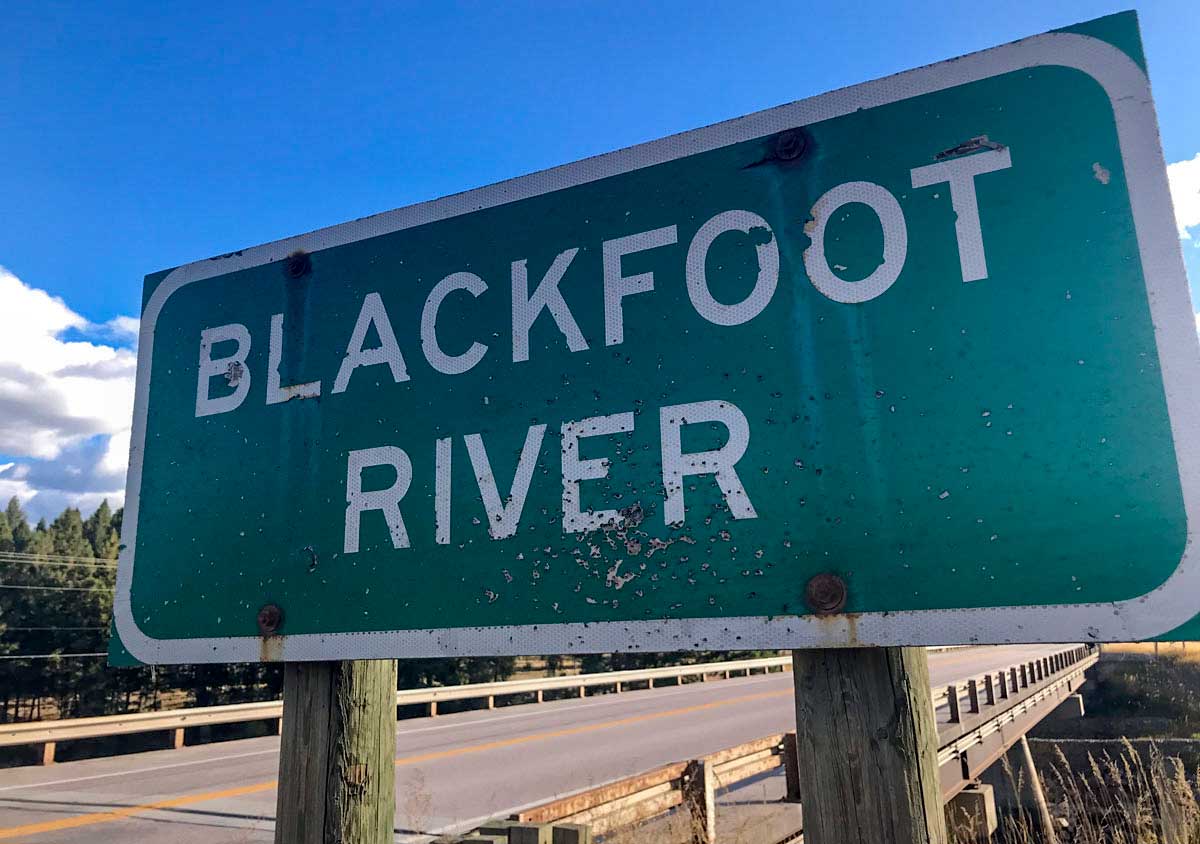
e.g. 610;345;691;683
114;26;1200;664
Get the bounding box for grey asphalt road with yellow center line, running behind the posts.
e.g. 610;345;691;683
0;646;1056;844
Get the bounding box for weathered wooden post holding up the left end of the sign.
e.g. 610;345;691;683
275;659;396;844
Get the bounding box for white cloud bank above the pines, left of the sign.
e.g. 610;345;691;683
0;268;138;515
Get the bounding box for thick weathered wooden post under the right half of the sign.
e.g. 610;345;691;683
792;647;947;844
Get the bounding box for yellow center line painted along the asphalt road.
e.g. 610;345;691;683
0;689;792;839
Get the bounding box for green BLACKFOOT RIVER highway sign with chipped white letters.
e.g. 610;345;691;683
115;13;1200;663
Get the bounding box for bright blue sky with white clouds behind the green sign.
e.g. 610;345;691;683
0;0;1200;514
